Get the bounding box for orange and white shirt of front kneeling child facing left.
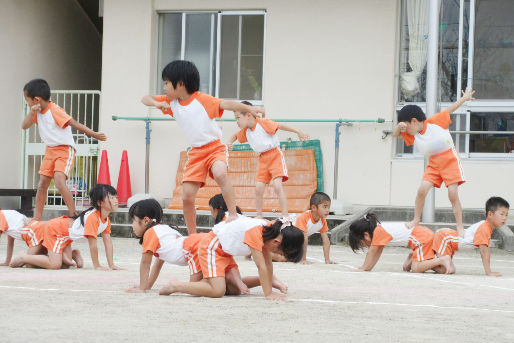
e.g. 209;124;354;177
143;224;187;266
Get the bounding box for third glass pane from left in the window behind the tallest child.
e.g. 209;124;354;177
219;15;239;99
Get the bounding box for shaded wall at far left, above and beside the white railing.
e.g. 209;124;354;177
0;0;101;208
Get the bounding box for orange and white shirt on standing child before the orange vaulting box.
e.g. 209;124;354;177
236;118;280;153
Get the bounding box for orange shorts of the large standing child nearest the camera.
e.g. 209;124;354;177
182;140;228;187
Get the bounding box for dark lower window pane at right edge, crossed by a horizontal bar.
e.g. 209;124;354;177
469;112;514;153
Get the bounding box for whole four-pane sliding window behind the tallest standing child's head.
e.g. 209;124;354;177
156;11;265;104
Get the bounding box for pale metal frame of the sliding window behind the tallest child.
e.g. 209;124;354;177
154;10;267;106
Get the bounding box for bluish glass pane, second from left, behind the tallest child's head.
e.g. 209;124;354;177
184;13;216;94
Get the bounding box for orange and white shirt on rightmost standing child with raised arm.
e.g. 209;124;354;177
402;110;454;156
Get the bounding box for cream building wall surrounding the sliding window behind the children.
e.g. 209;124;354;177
101;0;514;211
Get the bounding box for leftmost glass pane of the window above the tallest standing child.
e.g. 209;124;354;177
156;13;182;94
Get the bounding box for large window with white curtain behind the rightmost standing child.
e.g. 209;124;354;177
396;0;514;158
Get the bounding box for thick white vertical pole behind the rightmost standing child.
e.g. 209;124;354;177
422;0;441;223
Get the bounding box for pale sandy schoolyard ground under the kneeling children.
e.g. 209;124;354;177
0;237;514;342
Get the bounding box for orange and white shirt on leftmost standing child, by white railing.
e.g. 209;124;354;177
32;101;76;149
